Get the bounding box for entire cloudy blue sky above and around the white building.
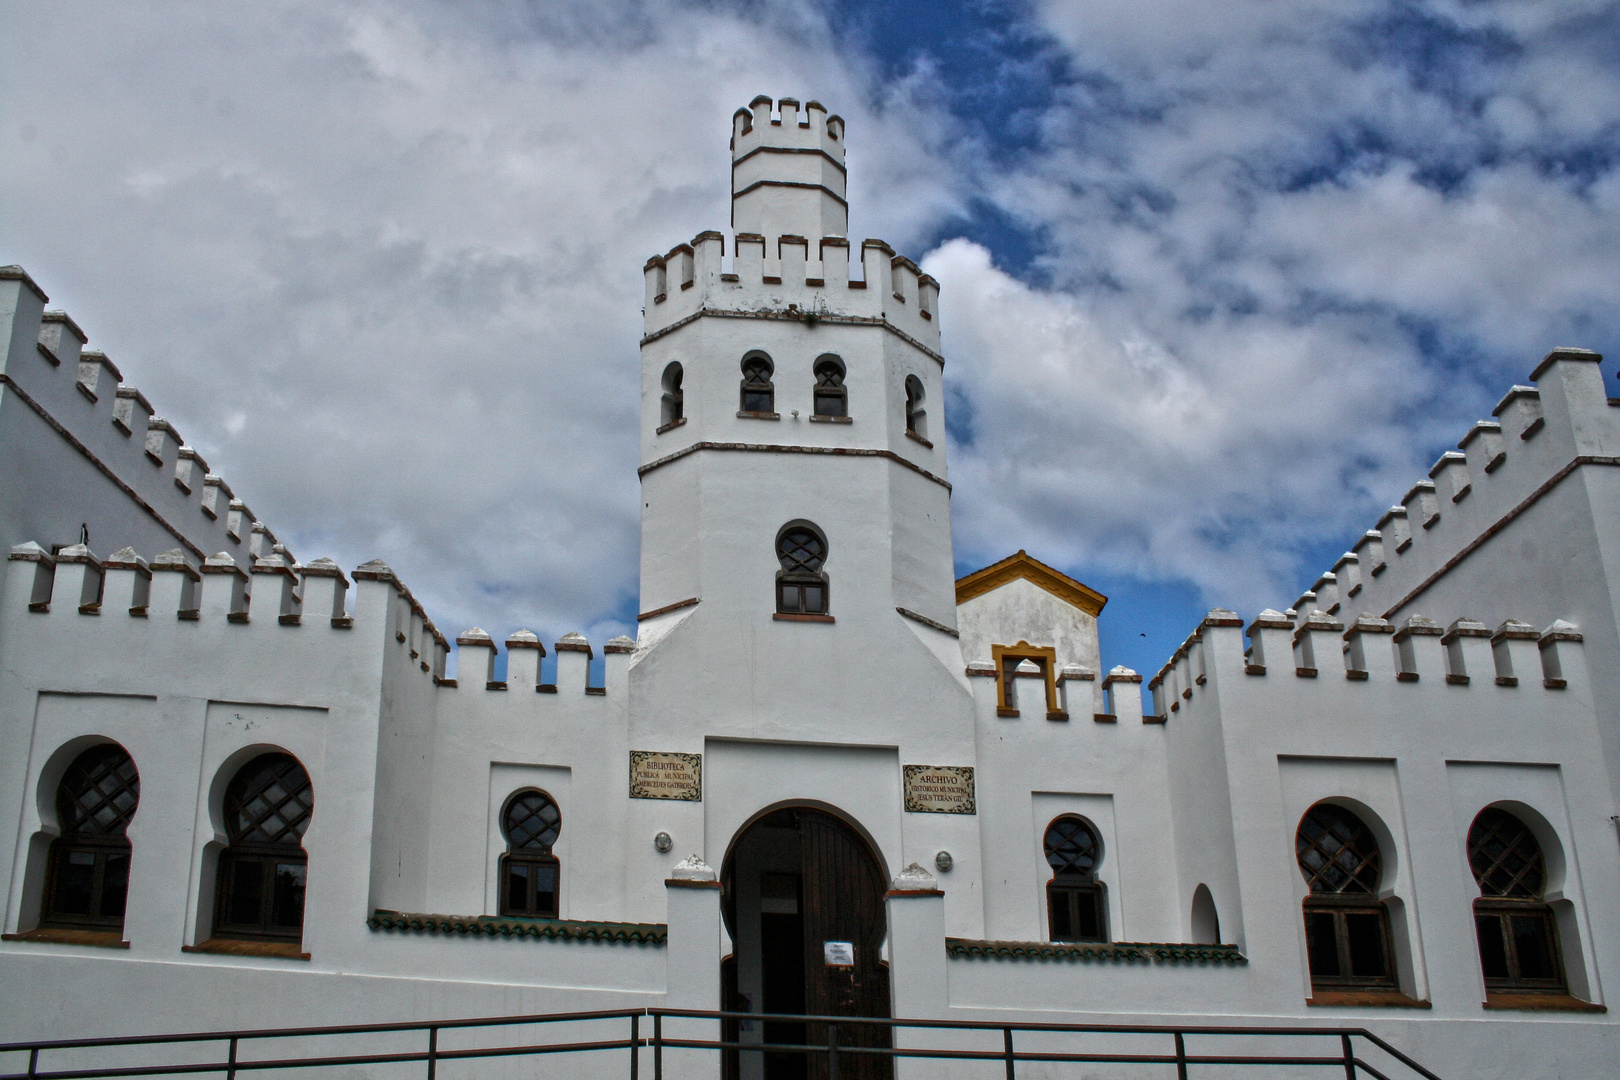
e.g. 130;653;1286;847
0;0;1620;689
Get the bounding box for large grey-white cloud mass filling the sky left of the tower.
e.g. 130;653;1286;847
0;2;953;636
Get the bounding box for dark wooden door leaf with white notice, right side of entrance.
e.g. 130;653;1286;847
799;810;894;1080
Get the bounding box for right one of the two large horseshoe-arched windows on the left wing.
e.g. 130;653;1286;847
214;753;314;941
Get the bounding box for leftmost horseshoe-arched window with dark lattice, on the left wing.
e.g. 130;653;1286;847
39;743;141;931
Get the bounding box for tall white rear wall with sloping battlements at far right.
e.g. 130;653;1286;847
1270;348;1620;803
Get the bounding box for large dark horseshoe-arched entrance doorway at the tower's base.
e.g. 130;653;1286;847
721;806;894;1080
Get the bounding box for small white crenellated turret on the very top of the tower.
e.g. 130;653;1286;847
731;94;849;241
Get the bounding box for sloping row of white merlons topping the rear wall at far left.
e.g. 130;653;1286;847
0;266;285;570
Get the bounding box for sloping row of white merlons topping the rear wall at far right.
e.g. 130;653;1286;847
1293;348;1620;622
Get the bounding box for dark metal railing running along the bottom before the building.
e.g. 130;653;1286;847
0;1009;1440;1080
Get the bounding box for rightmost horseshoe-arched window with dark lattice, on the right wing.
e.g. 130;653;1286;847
1468;806;1568;994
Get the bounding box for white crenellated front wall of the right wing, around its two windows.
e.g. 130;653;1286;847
1153;609;1620;1015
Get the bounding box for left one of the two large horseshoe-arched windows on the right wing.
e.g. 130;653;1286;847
1294;803;1395;989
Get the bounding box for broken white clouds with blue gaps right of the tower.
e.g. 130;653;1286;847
930;0;1620;606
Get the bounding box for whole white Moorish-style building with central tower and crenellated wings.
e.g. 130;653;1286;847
0;97;1620;1077
